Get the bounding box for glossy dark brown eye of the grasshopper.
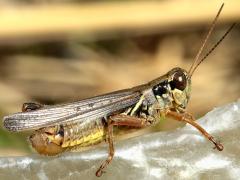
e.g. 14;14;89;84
170;72;187;91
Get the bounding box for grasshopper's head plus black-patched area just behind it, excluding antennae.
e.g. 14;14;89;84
152;68;191;112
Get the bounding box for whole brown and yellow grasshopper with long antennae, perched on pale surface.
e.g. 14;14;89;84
4;4;235;176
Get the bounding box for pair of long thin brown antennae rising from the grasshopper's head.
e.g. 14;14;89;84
188;3;230;77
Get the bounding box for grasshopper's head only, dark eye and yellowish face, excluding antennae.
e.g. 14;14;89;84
168;68;191;111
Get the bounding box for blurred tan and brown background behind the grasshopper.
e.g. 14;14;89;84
0;0;240;156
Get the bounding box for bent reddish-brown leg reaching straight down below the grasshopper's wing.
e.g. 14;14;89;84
96;114;148;177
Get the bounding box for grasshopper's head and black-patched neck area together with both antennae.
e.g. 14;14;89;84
153;4;236;112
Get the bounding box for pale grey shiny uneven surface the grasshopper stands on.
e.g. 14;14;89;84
0;101;240;179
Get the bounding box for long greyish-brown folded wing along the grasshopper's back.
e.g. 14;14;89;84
4;90;141;131
